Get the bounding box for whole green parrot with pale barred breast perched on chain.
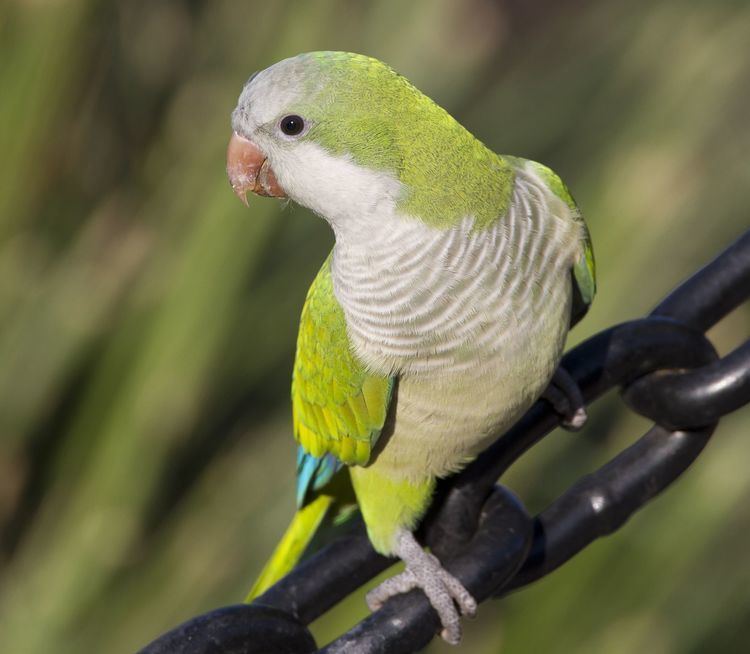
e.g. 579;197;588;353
227;52;595;643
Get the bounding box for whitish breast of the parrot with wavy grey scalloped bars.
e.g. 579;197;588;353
330;163;581;374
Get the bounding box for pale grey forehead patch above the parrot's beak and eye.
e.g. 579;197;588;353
232;57;315;131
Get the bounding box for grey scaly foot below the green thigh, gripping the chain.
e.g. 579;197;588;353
366;530;477;645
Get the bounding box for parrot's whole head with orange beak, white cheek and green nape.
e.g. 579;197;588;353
227;52;509;233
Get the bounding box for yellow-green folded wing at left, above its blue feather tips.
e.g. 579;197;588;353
292;257;394;482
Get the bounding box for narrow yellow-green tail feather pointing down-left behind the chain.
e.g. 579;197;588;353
245;495;333;603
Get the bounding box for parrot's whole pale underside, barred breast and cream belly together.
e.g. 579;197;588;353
332;164;582;477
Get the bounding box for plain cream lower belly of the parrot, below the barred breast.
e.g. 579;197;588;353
373;283;570;479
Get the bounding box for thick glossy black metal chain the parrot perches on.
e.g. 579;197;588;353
141;231;750;654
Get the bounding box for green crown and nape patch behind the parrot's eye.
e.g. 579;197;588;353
300;52;514;229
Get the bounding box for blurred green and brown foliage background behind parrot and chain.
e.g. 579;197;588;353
0;0;750;654
